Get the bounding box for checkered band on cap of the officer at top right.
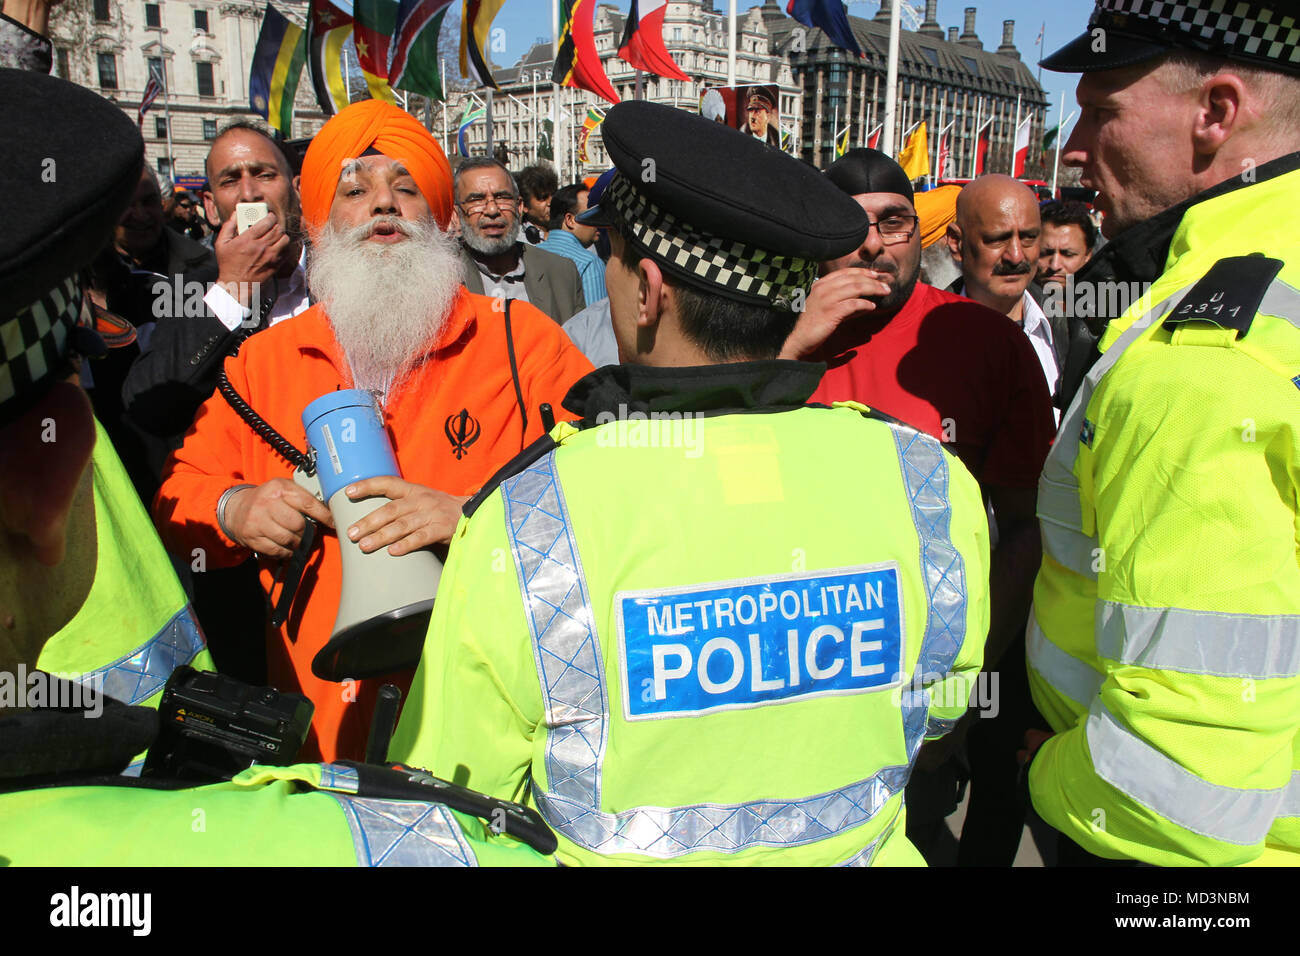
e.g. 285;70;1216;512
1089;0;1300;72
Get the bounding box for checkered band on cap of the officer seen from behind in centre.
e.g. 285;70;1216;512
601;173;818;308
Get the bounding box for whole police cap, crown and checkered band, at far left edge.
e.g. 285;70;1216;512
0;69;144;424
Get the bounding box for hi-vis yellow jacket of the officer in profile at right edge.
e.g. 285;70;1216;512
1028;156;1300;865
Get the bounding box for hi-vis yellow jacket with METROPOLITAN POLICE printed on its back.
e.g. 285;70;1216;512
390;392;988;866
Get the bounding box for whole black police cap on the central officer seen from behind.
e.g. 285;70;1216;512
580;100;868;308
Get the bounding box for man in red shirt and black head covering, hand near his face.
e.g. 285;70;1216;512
781;150;1054;865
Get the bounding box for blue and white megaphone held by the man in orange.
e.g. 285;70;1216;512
294;389;442;680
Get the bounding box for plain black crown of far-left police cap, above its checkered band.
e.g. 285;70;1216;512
0;69;144;317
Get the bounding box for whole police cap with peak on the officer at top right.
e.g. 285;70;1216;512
1043;0;1300;73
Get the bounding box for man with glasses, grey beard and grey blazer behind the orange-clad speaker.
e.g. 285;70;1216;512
455;156;586;324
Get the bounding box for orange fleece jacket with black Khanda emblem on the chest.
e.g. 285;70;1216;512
153;290;592;761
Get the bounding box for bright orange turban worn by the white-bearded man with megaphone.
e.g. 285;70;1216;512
302;100;451;229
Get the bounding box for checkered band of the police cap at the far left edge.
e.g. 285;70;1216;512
0;276;82;421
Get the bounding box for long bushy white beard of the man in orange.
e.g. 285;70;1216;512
307;216;460;395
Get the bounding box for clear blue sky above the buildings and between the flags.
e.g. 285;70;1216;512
493;0;1093;122
